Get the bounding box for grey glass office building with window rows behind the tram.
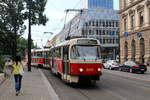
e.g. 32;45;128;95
55;9;119;59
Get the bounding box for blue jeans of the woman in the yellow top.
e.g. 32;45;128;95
14;74;22;92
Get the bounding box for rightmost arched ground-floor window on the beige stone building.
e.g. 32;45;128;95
140;38;145;63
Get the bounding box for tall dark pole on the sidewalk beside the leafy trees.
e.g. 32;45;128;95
28;0;32;72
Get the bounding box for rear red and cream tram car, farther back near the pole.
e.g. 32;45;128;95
31;49;50;67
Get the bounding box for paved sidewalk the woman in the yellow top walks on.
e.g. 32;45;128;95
0;68;59;100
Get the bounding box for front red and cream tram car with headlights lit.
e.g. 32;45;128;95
50;38;103;83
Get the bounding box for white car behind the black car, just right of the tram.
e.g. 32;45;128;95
104;60;119;70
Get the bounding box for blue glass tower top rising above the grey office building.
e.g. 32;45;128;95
81;0;113;10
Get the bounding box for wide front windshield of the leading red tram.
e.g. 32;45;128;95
71;45;100;60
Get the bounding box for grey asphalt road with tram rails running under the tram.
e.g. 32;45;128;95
43;70;150;100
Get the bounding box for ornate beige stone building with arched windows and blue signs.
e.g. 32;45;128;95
119;0;150;63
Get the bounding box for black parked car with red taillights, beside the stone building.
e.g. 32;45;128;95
119;61;147;74
